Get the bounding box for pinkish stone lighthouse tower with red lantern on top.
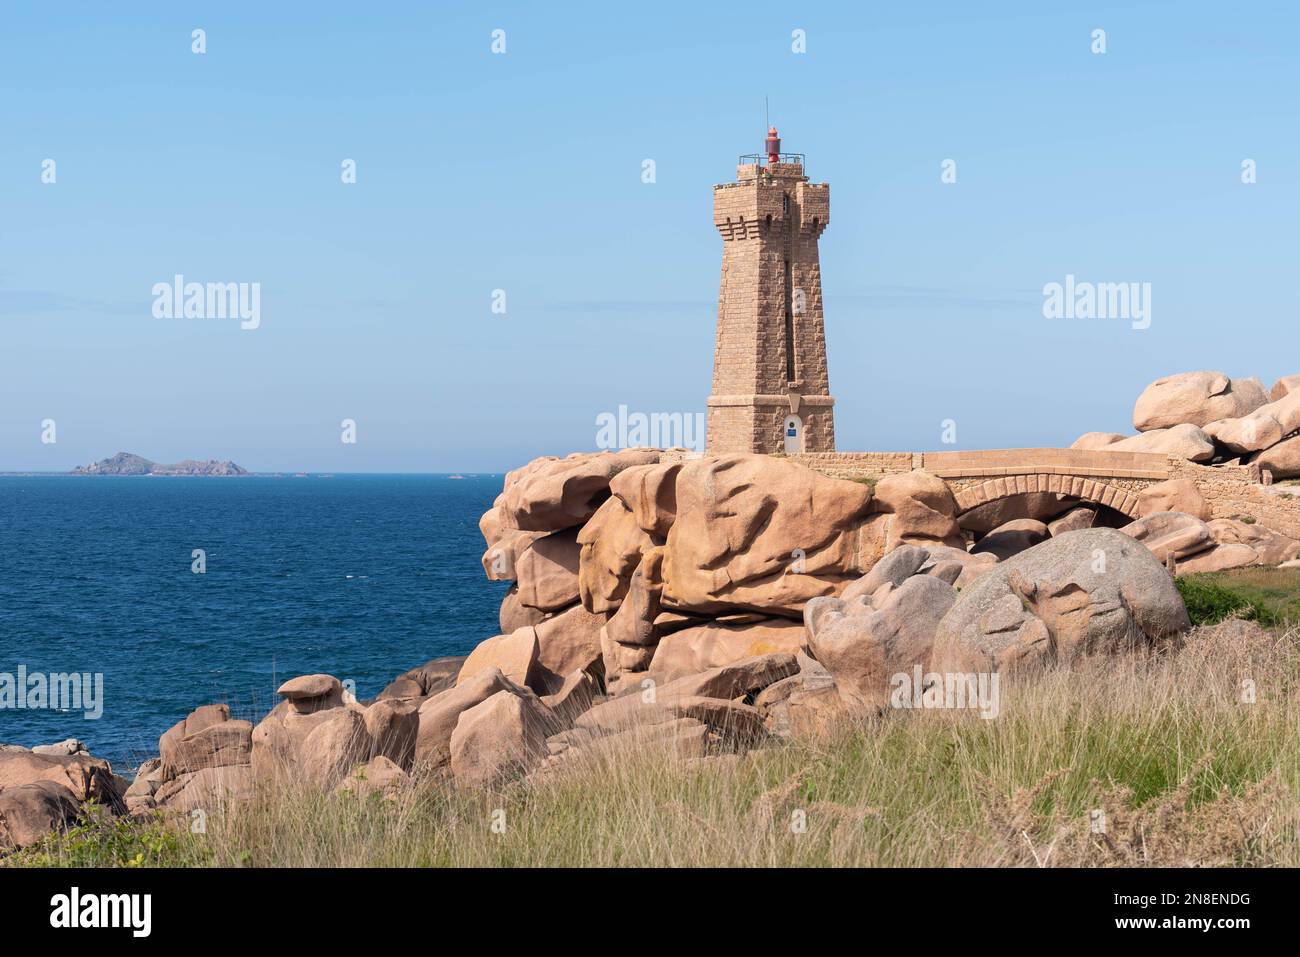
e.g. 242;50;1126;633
709;127;835;454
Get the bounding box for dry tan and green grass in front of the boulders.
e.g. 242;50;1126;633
10;622;1300;866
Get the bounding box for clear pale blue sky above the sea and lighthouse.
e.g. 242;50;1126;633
0;0;1300;471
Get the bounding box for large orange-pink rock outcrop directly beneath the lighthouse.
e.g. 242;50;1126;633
486;452;979;694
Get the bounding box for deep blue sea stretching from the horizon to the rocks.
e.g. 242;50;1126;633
0;475;506;770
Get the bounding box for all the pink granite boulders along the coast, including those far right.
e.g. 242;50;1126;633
0;373;1300;846
